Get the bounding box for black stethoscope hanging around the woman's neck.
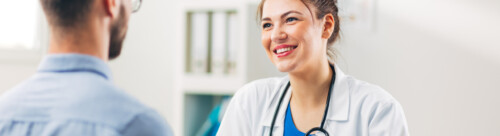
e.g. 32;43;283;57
269;65;335;136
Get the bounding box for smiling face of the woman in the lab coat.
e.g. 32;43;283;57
261;0;328;72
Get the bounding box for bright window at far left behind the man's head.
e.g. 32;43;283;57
0;0;48;60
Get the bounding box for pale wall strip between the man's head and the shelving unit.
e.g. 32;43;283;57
110;0;180;125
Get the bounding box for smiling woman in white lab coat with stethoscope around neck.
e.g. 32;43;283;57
217;0;409;136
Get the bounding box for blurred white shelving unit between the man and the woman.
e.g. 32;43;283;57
171;1;284;136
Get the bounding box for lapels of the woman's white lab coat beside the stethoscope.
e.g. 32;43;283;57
262;65;350;127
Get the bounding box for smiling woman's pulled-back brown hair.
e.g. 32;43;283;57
257;0;340;63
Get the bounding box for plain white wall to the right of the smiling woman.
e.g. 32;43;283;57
337;0;500;136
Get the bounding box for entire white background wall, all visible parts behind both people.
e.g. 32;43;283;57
0;0;500;136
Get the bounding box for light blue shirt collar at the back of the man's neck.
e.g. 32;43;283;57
38;53;111;80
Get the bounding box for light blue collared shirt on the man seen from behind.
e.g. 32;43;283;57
0;54;172;136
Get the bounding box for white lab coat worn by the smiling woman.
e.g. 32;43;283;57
217;67;409;136
